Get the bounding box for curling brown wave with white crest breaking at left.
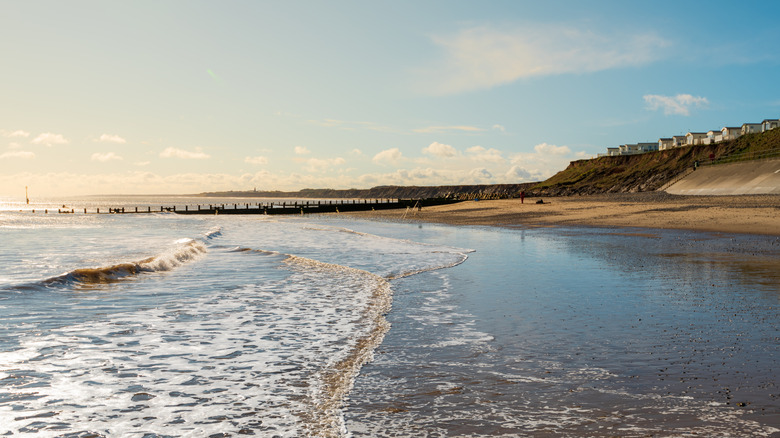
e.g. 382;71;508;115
29;239;207;289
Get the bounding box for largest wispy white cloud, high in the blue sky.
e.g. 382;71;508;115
420;24;669;94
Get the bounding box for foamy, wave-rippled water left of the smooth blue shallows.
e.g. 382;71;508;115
0;207;467;436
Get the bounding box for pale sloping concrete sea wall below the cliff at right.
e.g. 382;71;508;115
666;160;780;195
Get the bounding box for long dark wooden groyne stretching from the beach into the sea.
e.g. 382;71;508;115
32;198;460;215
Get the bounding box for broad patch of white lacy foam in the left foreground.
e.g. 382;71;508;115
0;252;389;436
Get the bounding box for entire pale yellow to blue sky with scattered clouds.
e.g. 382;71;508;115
0;0;780;198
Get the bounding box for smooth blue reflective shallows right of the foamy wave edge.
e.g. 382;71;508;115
346;225;780;436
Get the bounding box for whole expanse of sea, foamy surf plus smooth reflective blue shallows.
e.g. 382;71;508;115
0;197;780;438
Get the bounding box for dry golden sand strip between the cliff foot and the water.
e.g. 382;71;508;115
349;192;780;236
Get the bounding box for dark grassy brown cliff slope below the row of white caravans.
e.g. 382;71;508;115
530;129;780;196
